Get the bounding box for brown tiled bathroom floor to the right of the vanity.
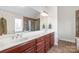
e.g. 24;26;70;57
48;40;76;53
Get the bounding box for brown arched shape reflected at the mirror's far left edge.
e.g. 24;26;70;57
0;17;7;35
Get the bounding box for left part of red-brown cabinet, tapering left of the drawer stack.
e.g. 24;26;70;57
1;40;35;53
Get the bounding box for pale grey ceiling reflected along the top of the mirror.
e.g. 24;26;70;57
0;6;40;18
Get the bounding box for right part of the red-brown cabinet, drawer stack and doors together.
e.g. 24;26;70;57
36;33;54;53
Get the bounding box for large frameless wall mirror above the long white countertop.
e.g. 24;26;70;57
0;6;41;37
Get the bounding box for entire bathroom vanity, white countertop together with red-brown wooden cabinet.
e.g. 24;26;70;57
0;31;54;53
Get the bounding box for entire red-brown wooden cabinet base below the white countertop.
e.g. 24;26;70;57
0;33;54;53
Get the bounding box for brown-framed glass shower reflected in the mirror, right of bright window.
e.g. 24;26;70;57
23;17;40;31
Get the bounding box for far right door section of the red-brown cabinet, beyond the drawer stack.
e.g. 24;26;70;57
44;33;54;52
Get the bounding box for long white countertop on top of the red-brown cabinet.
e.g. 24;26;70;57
0;30;54;51
